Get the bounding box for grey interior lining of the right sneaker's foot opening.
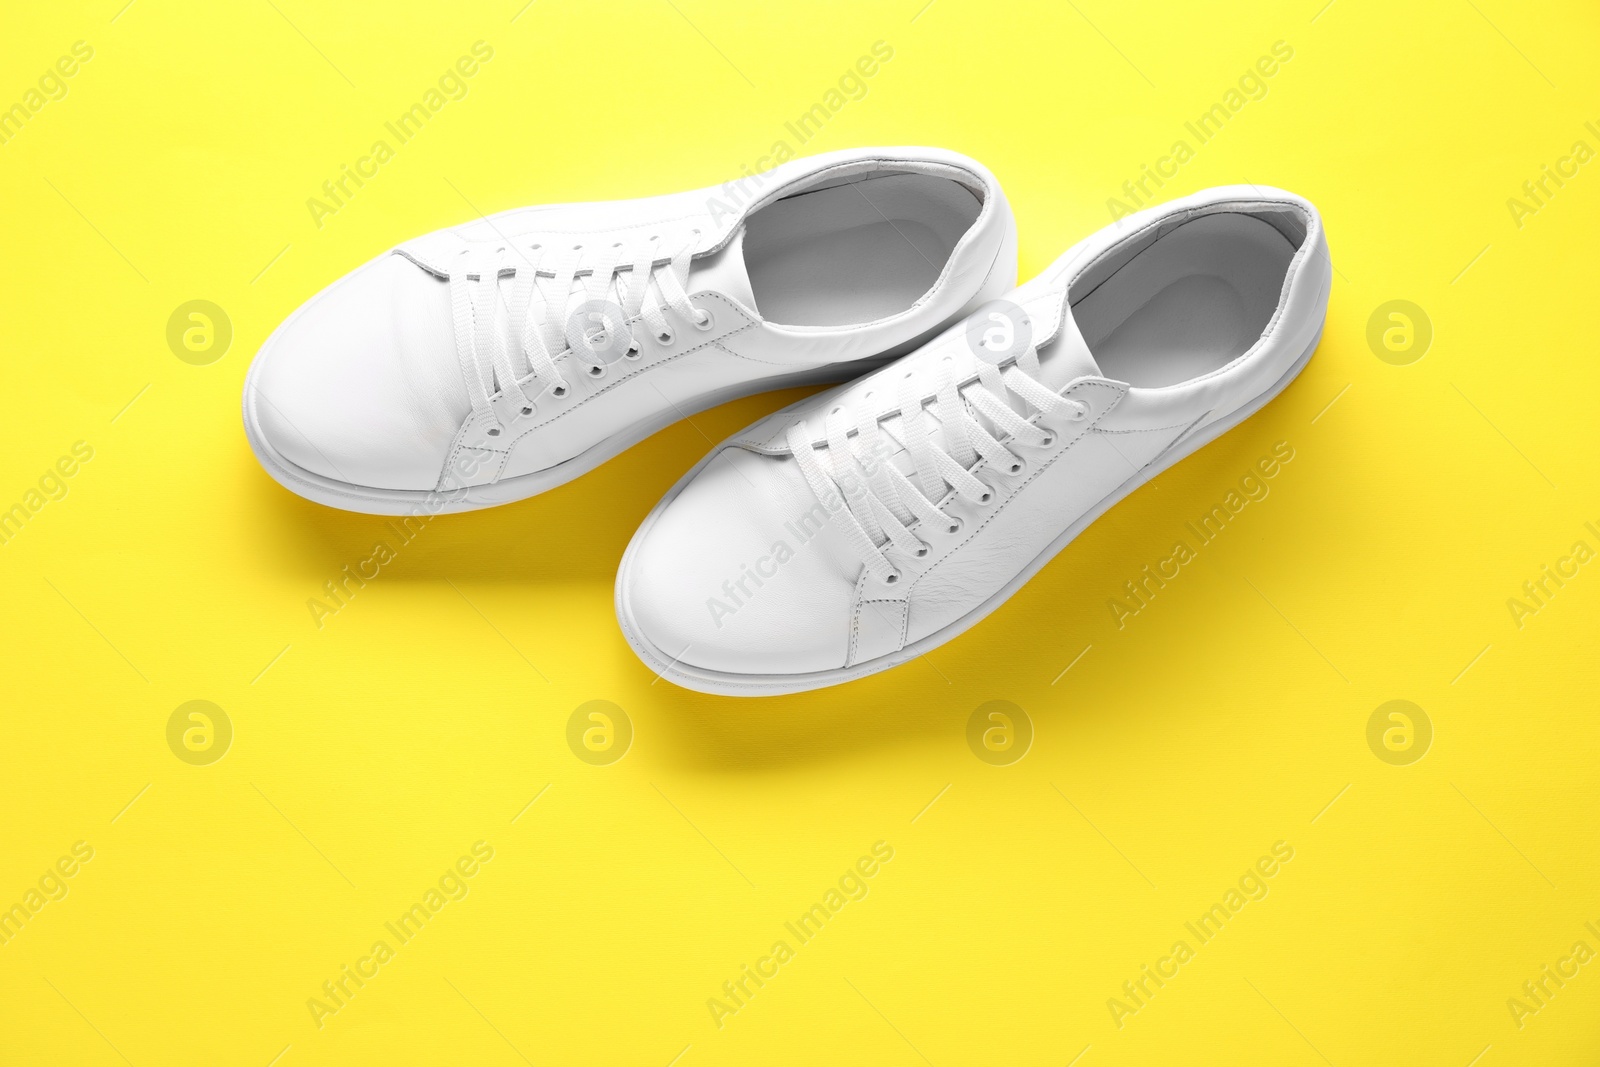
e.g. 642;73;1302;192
1069;208;1306;389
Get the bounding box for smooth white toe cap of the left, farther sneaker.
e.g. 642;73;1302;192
245;254;470;490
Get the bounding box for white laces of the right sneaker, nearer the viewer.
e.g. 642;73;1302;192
787;347;1090;585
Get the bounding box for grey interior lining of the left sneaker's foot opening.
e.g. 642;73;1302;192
744;171;982;326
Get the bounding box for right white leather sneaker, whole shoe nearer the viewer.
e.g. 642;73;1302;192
616;186;1331;696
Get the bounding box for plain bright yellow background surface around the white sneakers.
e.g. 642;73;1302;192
0;0;1600;1067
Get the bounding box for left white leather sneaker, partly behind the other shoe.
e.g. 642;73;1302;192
245;149;1016;515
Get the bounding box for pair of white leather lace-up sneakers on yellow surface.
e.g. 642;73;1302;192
245;149;1331;696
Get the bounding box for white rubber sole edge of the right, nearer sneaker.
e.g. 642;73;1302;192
616;326;1322;696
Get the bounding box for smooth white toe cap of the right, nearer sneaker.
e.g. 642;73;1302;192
621;448;861;675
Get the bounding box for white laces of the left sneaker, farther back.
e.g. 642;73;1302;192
450;230;712;437
